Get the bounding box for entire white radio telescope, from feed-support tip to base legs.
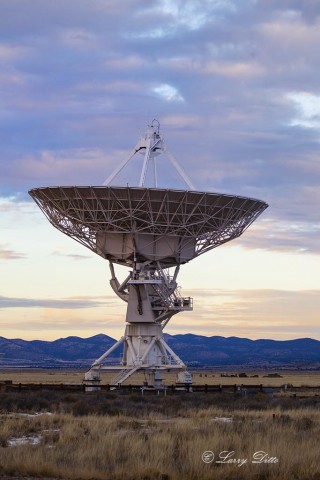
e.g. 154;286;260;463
29;119;268;389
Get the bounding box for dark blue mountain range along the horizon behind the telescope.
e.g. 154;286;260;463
0;333;320;368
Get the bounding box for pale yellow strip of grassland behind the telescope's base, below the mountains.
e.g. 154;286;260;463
0;369;320;387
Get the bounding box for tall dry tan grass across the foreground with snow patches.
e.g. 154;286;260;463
0;394;320;480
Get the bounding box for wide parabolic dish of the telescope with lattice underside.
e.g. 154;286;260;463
29;186;268;267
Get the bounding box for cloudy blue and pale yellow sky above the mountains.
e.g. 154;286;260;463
0;0;320;340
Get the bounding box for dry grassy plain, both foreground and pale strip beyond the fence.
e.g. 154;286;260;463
0;371;320;480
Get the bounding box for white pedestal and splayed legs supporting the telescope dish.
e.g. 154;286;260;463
85;262;192;387
